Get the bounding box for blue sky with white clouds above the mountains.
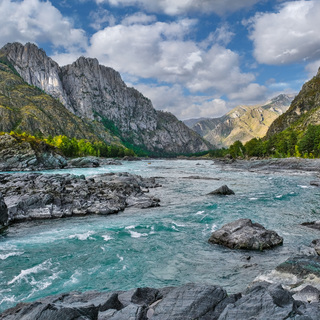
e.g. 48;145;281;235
0;0;320;120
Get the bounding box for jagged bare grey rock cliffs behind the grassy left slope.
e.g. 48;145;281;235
0;43;211;154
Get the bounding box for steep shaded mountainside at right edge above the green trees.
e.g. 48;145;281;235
266;68;320;138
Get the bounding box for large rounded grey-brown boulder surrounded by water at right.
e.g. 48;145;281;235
209;219;283;250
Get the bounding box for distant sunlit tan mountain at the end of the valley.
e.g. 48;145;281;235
185;94;294;148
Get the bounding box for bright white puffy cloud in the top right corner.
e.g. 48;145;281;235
249;1;320;65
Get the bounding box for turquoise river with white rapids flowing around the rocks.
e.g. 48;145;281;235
0;160;320;312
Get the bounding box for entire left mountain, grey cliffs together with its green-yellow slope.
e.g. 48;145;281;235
0;43;212;155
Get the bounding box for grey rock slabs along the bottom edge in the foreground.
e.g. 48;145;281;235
0;283;320;320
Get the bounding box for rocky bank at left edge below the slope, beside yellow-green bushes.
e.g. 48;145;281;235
0;134;67;171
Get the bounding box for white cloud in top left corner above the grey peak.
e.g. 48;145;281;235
0;0;87;50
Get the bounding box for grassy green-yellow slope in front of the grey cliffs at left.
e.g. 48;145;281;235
0;55;120;144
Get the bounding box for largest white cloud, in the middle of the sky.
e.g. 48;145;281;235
88;14;255;103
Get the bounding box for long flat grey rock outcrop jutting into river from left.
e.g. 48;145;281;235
0;173;159;223
